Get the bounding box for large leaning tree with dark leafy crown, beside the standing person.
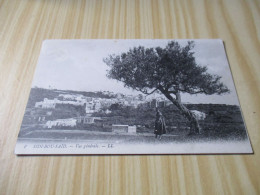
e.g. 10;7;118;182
104;41;229;134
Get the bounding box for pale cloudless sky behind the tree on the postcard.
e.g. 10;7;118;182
32;39;239;105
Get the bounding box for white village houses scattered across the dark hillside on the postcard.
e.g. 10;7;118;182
35;92;206;133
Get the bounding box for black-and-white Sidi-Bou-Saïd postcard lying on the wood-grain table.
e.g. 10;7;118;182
15;39;253;155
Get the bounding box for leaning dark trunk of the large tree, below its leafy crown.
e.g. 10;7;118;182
160;90;200;135
